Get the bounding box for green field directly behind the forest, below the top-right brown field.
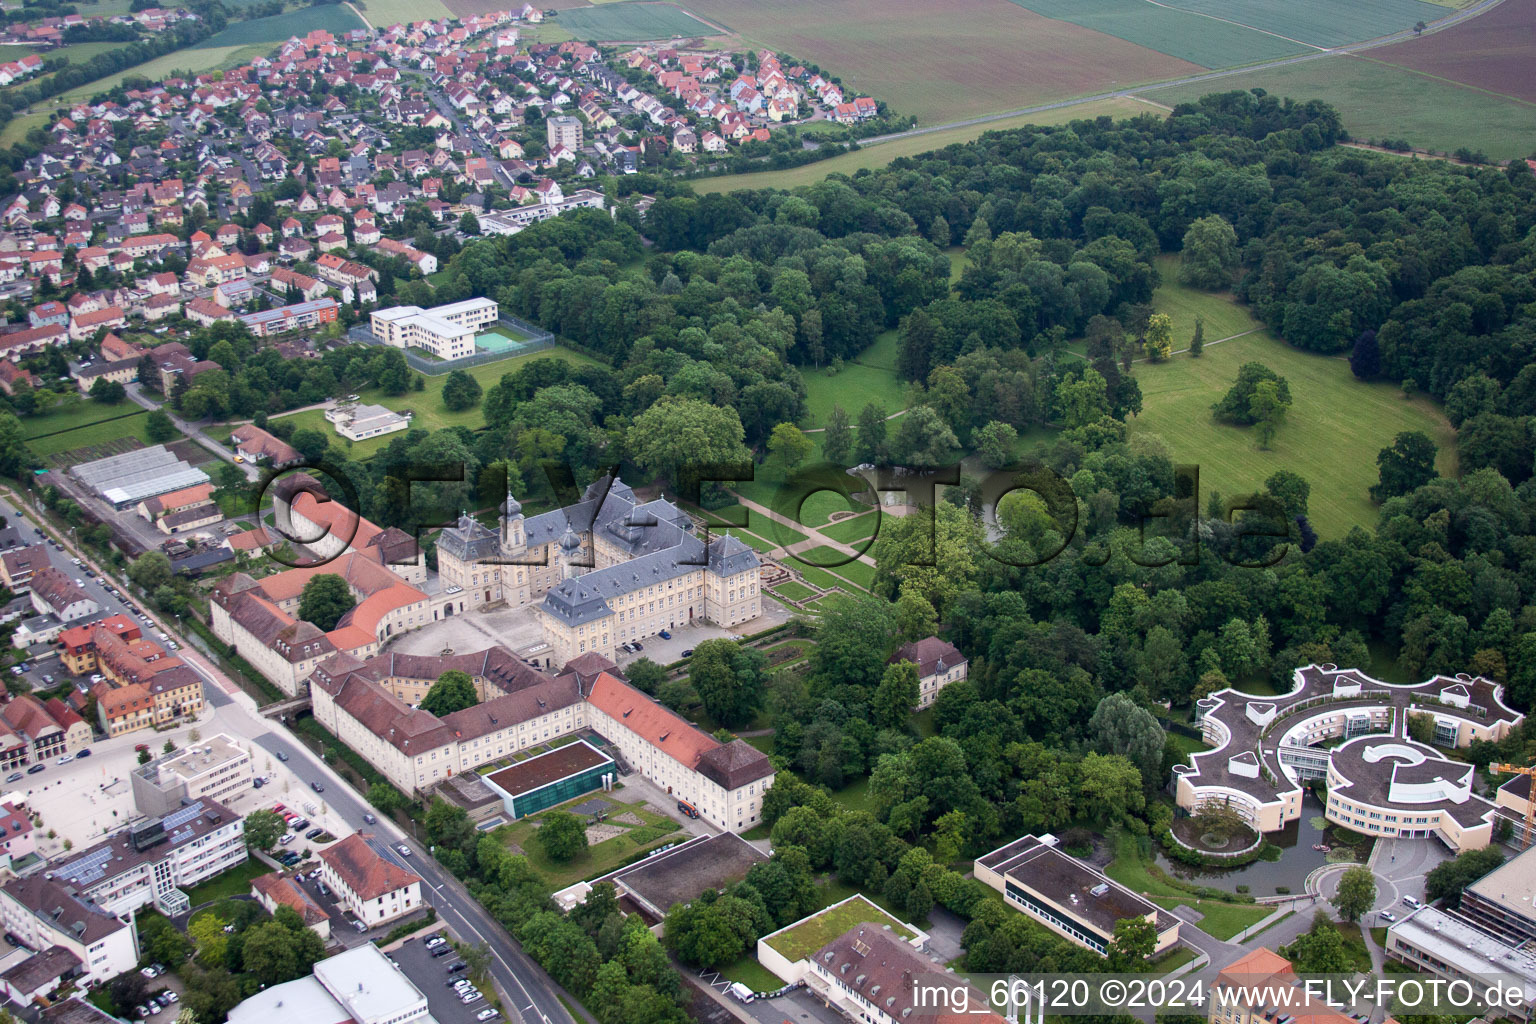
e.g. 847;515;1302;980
1147;57;1536;160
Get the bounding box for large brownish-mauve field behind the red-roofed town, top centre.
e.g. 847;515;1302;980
675;0;1198;124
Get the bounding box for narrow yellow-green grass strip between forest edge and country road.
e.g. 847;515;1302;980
693;97;1161;193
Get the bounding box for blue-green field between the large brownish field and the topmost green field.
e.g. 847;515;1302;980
1012;0;1308;68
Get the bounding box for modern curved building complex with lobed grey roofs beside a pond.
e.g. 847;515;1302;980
1174;665;1525;852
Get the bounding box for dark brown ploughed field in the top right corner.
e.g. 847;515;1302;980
1370;0;1536;103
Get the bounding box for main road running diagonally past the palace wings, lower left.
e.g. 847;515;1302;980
0;488;574;1024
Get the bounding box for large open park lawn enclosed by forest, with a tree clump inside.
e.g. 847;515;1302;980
1130;332;1456;539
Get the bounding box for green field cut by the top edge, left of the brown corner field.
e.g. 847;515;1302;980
1155;0;1448;49
